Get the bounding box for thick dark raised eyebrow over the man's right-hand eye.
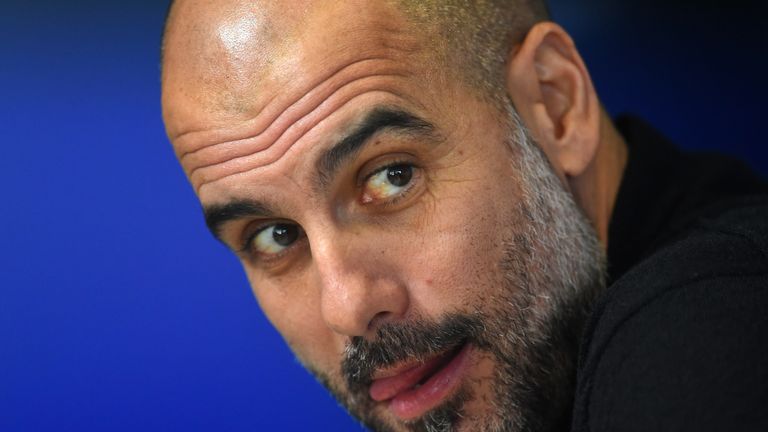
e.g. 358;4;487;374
315;107;437;190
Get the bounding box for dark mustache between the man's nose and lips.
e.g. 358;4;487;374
341;313;485;393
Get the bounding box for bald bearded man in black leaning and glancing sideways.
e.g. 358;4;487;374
162;0;768;431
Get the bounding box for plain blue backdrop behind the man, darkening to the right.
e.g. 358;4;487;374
0;0;768;432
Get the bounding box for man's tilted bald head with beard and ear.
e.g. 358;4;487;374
163;0;621;430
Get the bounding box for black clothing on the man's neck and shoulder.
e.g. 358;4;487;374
572;119;768;432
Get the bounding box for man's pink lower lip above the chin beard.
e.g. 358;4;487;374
389;344;470;420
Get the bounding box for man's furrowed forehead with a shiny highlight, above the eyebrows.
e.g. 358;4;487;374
163;0;450;203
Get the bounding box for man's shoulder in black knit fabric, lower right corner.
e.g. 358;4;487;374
574;199;768;431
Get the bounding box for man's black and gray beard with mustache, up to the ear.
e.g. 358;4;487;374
306;106;605;432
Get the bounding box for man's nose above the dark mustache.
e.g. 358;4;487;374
312;236;409;336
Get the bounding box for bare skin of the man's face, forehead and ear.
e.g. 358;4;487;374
162;0;626;428
